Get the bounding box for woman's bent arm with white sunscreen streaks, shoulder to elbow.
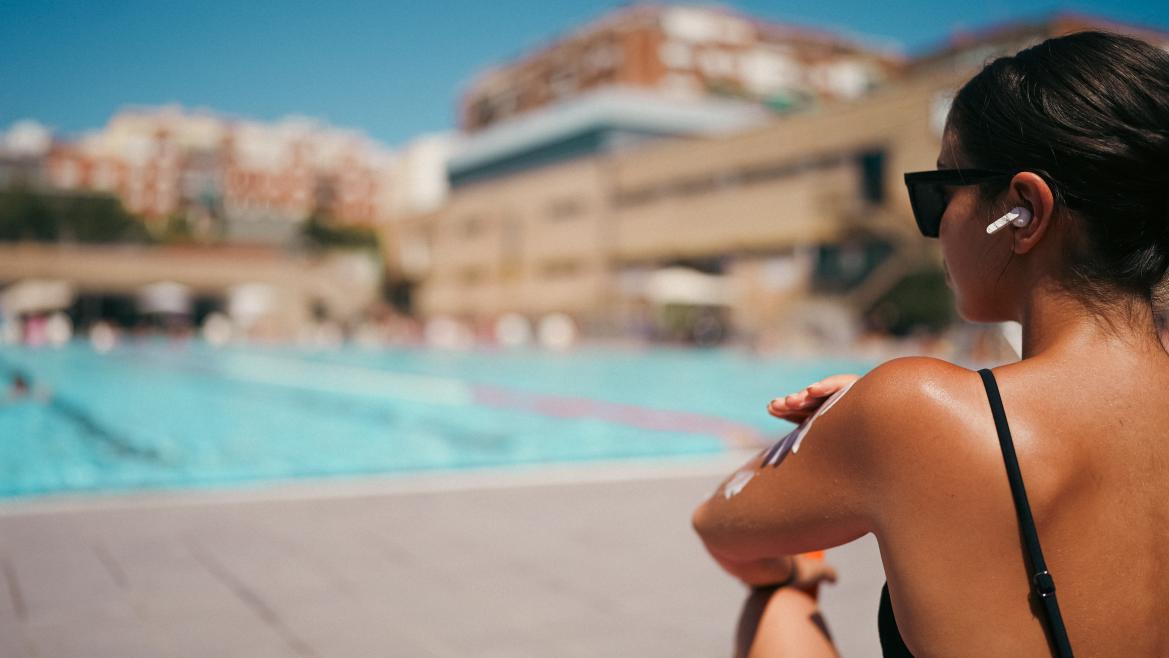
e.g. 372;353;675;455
693;358;954;560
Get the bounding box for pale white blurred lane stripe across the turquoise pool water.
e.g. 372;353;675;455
221;355;473;406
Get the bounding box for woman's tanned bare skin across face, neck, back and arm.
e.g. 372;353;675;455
693;132;1169;657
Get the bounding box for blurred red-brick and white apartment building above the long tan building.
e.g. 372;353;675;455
459;5;901;132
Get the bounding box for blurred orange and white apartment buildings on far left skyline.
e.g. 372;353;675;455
28;106;447;244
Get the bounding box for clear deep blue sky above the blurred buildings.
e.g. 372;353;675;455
0;0;1169;145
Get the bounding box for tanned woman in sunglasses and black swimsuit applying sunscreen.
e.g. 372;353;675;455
693;33;1169;657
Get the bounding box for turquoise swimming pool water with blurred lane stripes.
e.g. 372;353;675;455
0;341;874;497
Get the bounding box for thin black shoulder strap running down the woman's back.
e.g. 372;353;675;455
978;368;1072;657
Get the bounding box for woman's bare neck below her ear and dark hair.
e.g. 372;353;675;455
1019;288;1169;363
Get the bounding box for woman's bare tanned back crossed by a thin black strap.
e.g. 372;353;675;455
876;349;1169;656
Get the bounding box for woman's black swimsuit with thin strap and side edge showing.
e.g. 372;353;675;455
877;368;1072;658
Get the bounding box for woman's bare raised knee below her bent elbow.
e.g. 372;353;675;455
735;587;837;658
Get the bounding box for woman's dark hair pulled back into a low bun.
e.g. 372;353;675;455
948;32;1169;304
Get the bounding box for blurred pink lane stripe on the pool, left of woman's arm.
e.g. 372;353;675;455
471;385;763;445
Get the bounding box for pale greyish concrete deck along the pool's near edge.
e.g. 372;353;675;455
0;455;883;658
